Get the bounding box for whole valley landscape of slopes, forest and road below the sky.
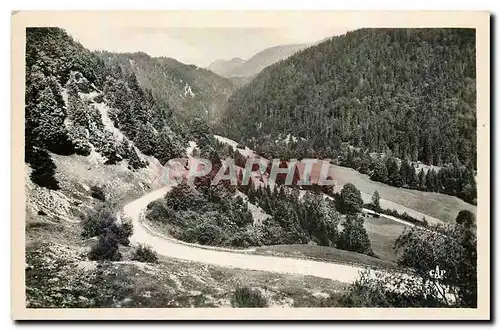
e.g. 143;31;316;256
24;27;477;308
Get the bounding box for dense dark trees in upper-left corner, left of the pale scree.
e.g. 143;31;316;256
25;28;104;155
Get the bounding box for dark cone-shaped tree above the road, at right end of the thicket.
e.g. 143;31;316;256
337;215;373;255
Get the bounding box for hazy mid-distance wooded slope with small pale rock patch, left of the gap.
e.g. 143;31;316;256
97;52;234;121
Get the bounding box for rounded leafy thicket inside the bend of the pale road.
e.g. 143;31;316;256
147;183;254;247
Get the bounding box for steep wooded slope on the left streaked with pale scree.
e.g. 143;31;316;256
25;28;186;189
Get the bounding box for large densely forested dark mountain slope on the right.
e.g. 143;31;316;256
222;29;476;167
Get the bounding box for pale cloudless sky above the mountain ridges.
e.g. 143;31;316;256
60;24;347;67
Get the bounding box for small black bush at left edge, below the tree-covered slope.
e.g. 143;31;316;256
25;148;60;190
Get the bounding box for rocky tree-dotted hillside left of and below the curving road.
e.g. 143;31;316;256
23;28;356;308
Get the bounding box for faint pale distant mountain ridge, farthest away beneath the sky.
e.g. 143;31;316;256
207;44;308;78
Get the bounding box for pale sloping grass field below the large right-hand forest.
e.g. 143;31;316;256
329;165;476;224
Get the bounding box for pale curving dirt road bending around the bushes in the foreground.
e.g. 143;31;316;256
123;186;363;283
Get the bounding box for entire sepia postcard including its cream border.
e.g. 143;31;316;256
11;11;490;320
